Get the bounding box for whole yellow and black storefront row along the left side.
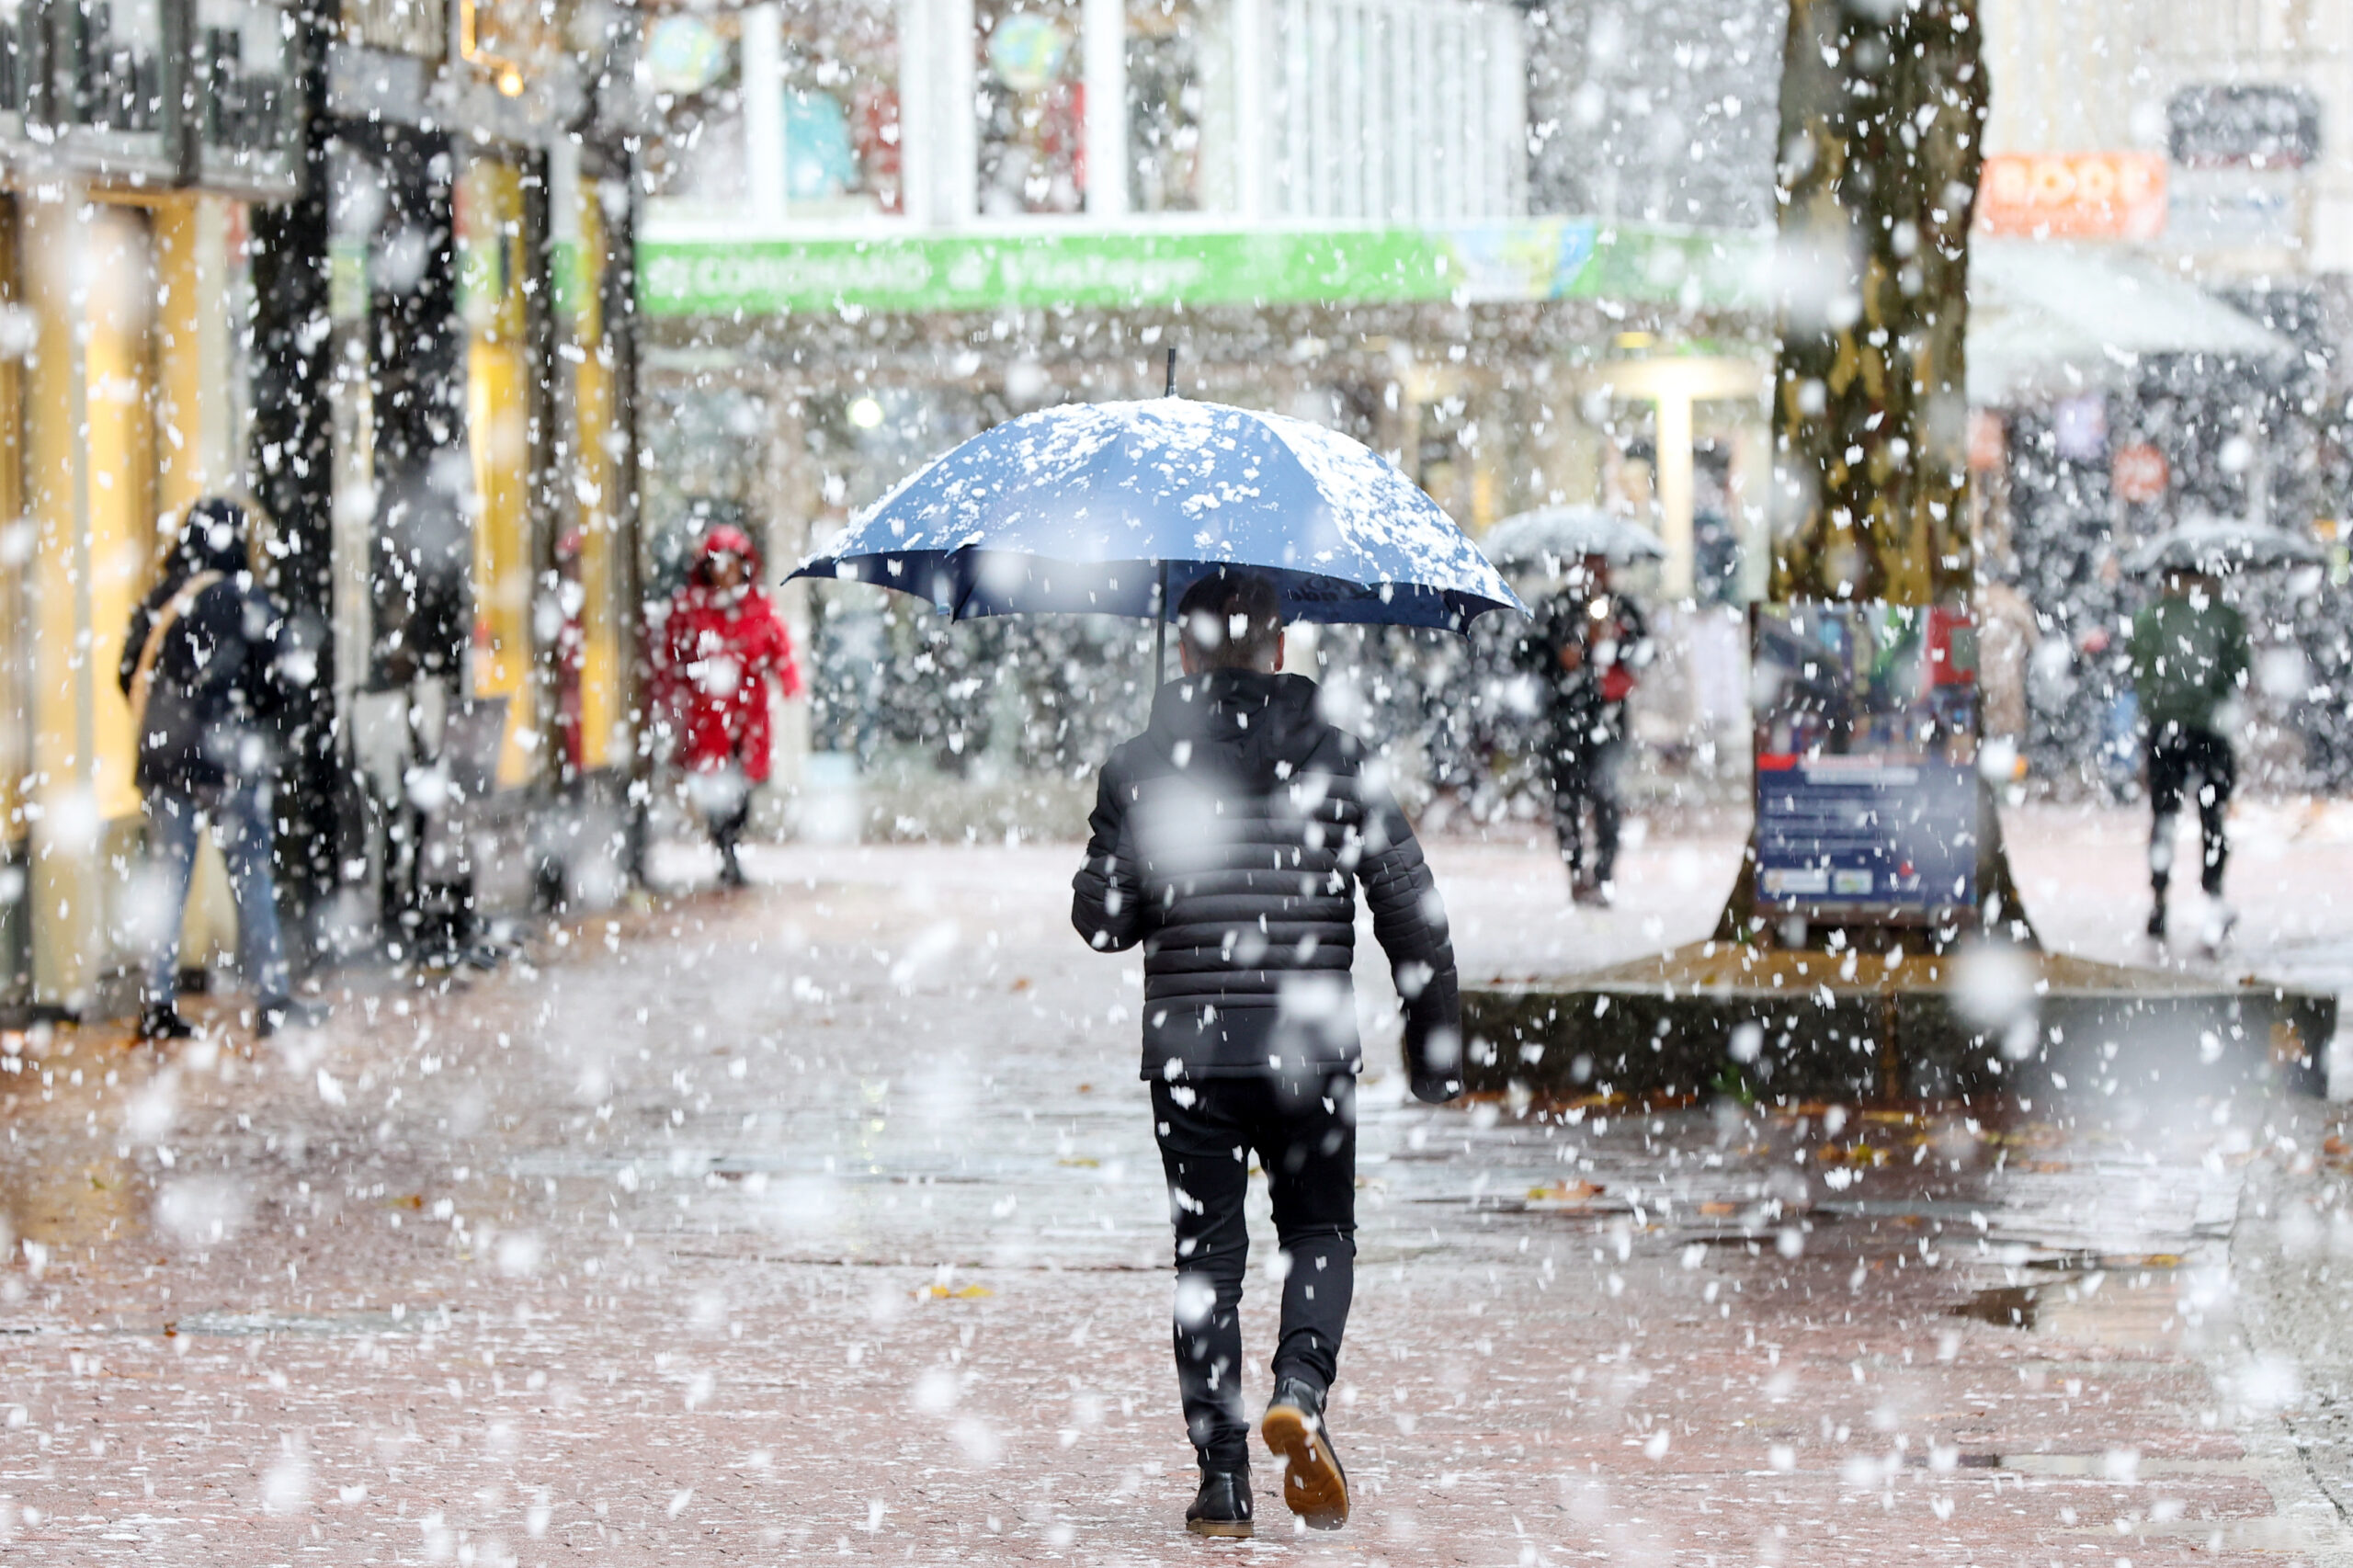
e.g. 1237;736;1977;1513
0;0;629;1015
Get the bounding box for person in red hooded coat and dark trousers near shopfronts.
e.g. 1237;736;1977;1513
654;525;800;888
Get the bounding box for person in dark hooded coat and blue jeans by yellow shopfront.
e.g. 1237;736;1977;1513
118;496;318;1039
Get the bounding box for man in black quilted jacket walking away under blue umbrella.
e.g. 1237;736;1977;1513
1071;572;1461;1535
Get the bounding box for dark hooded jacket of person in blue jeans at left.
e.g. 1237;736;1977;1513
118;528;285;793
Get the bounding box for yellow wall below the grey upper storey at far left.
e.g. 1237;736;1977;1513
0;193;254;1007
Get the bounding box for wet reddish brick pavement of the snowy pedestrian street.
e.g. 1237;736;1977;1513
0;808;2353;1565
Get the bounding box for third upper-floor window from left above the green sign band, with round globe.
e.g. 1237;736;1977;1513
974;0;1087;217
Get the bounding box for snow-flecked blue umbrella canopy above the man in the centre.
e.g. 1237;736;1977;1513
793;398;1527;631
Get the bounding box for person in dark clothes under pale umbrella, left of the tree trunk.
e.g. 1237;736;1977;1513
1520;556;1650;904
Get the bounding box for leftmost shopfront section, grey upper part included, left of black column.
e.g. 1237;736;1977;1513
0;0;301;1012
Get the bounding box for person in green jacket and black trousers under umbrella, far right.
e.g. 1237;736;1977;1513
2131;567;2252;944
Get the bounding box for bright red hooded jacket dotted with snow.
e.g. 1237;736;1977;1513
652;525;800;784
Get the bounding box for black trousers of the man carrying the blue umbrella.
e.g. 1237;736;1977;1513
1153;1074;1356;1469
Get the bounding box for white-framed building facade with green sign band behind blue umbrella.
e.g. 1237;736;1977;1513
638;0;1762;805
